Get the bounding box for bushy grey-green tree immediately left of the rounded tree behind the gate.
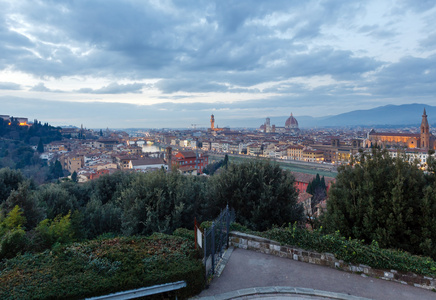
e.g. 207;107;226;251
119;170;208;235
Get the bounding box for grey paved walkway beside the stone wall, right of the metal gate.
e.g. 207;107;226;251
194;248;436;300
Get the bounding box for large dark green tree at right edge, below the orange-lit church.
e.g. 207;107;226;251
324;148;436;255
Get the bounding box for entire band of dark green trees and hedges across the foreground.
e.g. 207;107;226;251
0;149;436;299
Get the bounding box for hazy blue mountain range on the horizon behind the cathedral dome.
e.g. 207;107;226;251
223;103;436;128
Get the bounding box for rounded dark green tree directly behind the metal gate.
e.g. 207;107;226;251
209;160;303;230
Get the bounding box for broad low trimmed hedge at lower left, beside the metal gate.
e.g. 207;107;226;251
0;234;205;299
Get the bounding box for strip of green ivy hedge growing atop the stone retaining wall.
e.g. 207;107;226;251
235;224;436;277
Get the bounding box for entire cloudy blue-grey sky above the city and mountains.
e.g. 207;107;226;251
0;0;436;128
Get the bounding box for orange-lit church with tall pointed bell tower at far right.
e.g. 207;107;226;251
365;108;436;150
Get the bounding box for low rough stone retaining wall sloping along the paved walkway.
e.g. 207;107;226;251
230;231;436;291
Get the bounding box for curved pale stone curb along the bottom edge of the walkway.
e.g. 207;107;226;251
191;286;370;300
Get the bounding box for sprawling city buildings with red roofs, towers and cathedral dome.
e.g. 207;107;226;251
31;110;436;184
